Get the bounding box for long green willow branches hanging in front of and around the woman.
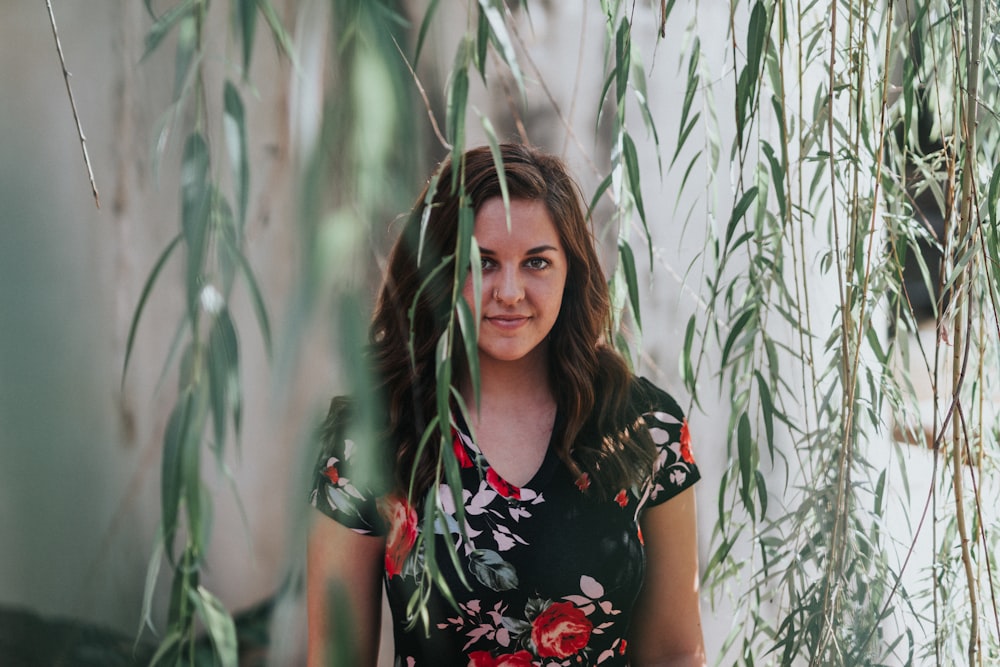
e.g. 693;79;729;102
125;0;1000;665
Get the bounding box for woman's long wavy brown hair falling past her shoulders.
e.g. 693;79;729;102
370;144;654;496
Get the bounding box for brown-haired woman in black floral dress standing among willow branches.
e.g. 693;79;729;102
308;144;705;667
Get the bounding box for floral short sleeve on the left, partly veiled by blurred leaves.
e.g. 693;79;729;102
310;397;386;535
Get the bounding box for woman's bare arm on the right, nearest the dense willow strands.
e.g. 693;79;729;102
628;488;706;667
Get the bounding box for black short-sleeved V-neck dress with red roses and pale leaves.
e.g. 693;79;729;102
312;378;700;667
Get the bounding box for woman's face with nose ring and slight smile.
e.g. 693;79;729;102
462;197;568;365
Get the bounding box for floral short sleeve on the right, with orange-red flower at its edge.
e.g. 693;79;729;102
638;378;701;507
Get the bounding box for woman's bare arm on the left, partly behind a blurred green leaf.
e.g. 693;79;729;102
306;512;385;667
